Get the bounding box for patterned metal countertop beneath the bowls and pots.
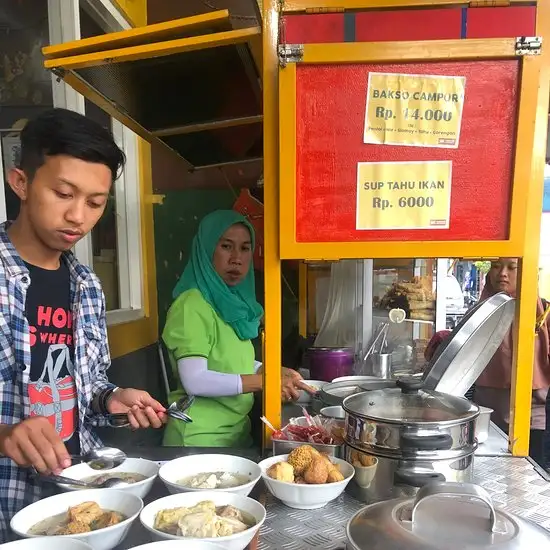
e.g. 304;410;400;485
117;446;550;550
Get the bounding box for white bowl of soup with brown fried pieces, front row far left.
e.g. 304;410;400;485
10;489;143;550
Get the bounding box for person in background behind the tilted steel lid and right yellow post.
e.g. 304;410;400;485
426;258;550;467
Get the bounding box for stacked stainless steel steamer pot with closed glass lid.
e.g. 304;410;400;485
343;380;479;502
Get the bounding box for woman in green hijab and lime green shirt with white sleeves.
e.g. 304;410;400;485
162;210;308;447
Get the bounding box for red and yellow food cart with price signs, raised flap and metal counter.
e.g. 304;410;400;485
41;0;550;548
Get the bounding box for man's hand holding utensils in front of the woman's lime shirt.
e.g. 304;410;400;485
107;388;168;430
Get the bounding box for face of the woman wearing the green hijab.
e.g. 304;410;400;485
212;223;252;286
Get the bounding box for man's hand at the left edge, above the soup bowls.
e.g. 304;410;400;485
0;416;71;474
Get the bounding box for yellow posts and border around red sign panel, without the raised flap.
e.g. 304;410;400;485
264;0;550;456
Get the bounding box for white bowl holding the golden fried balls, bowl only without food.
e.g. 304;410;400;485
259;455;355;510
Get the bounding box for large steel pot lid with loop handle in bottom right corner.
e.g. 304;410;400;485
347;482;550;550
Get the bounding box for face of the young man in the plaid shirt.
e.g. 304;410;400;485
9;155;112;252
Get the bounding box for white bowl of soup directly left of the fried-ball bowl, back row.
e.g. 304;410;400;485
159;454;262;496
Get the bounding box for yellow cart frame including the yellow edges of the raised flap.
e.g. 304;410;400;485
44;0;550;455
